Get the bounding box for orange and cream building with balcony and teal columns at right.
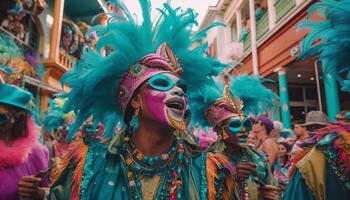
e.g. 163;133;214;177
200;0;350;128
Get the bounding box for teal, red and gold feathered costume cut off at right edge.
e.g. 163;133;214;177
283;124;350;200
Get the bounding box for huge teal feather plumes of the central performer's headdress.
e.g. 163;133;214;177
61;0;226;140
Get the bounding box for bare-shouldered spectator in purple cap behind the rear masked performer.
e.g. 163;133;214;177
252;115;278;171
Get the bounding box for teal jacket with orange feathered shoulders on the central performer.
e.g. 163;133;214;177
47;129;238;200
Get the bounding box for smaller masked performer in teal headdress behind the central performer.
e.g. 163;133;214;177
188;75;278;199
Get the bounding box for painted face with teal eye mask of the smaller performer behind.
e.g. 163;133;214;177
221;116;252;146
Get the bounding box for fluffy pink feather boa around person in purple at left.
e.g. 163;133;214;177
0;117;39;167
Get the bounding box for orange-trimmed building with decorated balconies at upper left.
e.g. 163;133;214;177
0;0;114;111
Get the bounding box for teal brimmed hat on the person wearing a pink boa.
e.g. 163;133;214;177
0;83;32;112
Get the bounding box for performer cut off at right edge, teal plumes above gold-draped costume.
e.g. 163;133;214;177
284;0;350;200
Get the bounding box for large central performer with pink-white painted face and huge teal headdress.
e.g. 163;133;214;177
44;0;241;200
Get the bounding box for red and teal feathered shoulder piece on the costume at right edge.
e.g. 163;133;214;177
291;123;350;189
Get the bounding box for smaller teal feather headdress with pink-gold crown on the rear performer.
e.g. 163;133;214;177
188;74;279;127
